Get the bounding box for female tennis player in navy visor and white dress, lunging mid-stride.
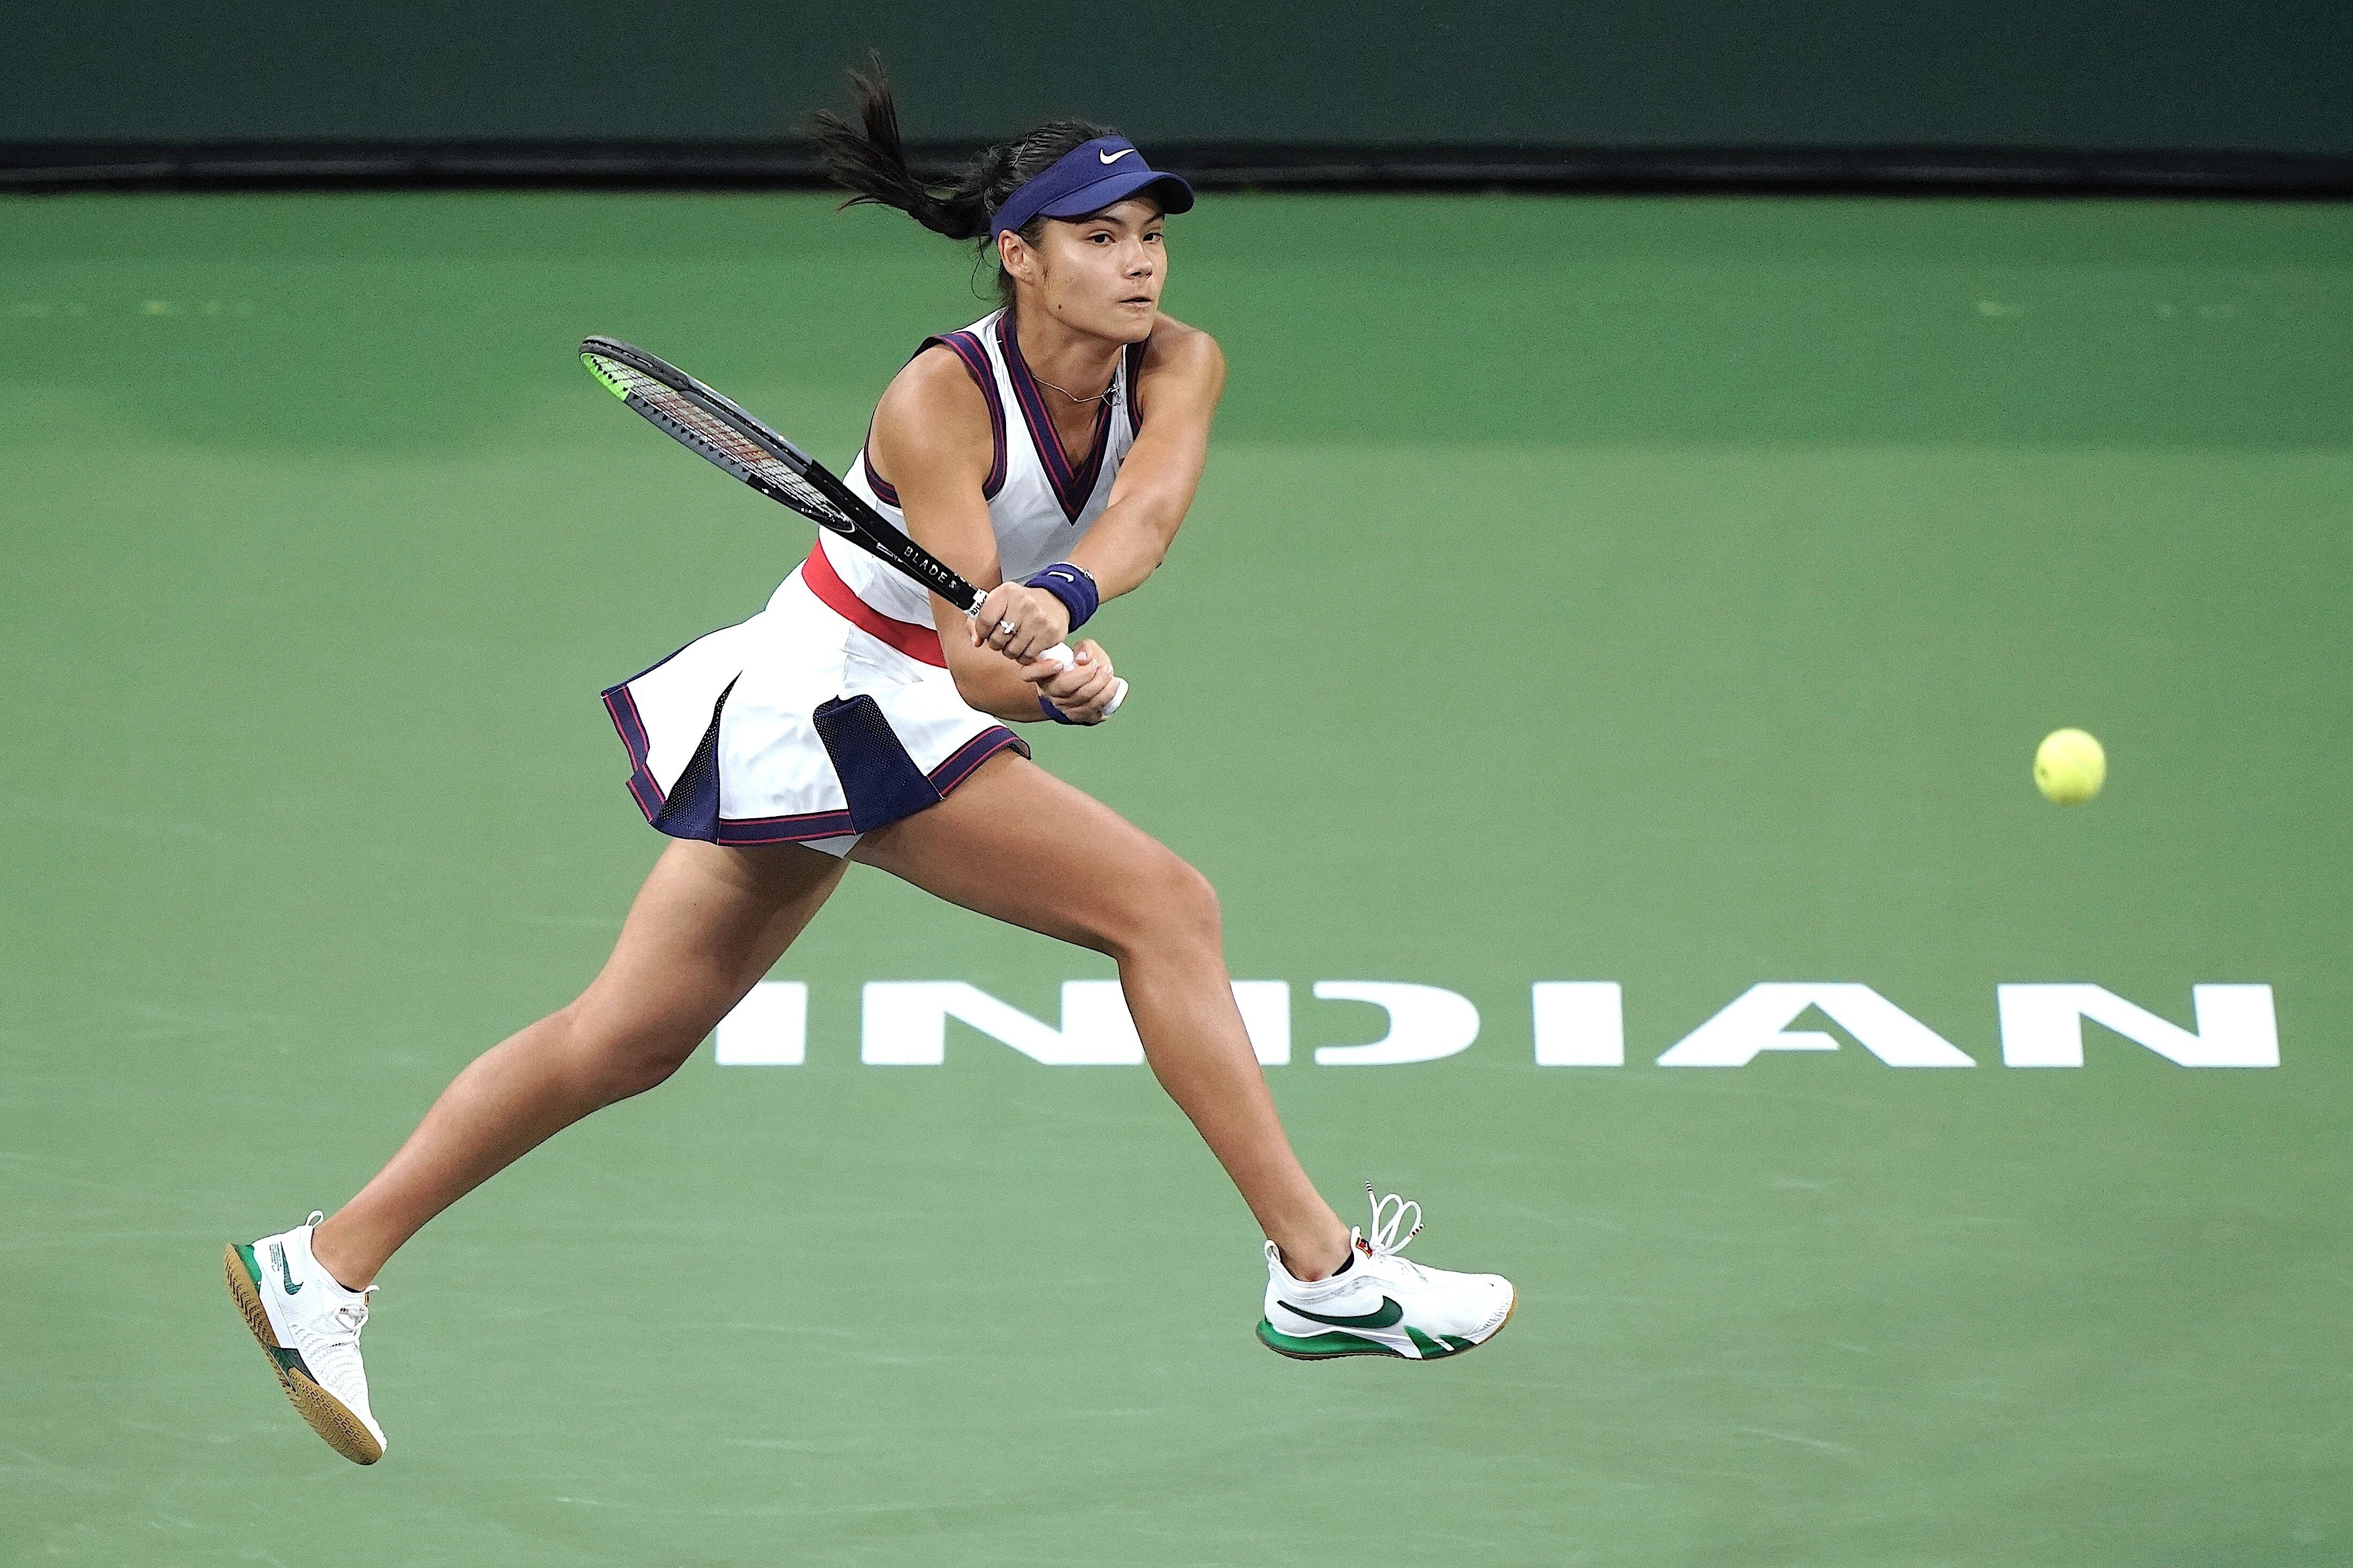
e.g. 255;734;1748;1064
226;73;1513;1465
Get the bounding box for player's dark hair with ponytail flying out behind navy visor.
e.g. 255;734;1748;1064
809;54;1118;305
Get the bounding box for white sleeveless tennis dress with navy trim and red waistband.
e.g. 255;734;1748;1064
588;310;1144;856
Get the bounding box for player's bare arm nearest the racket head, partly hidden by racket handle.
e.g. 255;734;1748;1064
866;343;1111;724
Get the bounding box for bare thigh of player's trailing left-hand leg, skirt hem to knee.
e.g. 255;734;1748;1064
572;839;843;1039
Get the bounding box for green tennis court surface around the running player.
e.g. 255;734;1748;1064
0;193;2353;1568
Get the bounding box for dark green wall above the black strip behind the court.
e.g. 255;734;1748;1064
13;0;2353;153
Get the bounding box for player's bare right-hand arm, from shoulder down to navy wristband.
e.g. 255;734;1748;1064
1070;315;1226;600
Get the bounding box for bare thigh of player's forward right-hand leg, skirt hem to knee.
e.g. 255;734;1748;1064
852;752;1217;954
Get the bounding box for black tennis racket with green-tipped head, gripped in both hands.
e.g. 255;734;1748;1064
581;339;1127;719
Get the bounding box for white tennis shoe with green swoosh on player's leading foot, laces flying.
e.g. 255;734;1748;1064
1259;1183;1518;1361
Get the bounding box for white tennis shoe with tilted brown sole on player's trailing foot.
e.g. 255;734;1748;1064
221;1213;384;1465
